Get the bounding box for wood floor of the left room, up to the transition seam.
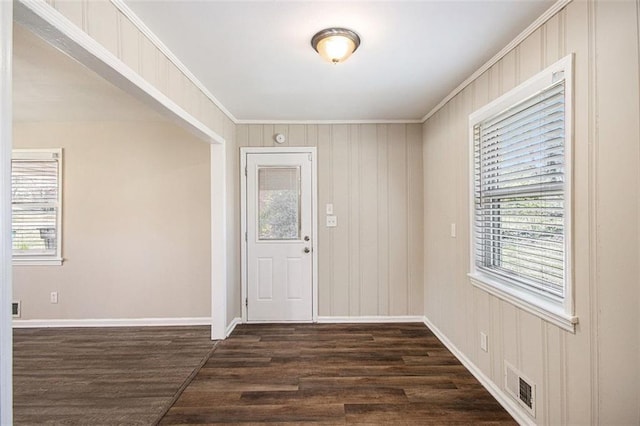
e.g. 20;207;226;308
13;326;215;425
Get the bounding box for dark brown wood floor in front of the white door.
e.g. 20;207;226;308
160;324;515;425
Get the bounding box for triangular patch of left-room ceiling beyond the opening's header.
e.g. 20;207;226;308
13;24;165;122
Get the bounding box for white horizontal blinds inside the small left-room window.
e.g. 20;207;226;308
11;154;59;256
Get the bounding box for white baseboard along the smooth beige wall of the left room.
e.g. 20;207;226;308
13;317;211;328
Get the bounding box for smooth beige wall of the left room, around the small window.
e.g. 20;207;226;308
14;122;211;319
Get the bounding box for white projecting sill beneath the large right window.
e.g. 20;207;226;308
468;273;578;333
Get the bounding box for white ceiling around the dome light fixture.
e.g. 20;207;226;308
126;0;554;121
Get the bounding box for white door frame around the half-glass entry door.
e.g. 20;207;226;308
240;146;318;323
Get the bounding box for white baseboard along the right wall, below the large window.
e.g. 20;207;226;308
422;317;536;426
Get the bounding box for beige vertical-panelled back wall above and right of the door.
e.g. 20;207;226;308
236;124;423;316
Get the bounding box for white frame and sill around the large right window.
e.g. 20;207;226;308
468;54;578;332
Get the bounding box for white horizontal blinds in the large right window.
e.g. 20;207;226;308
474;80;565;297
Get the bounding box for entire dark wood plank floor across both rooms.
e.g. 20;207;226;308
14;323;515;425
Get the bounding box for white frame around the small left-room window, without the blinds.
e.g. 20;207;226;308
12;148;63;266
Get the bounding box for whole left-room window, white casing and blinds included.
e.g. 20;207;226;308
11;149;62;265
